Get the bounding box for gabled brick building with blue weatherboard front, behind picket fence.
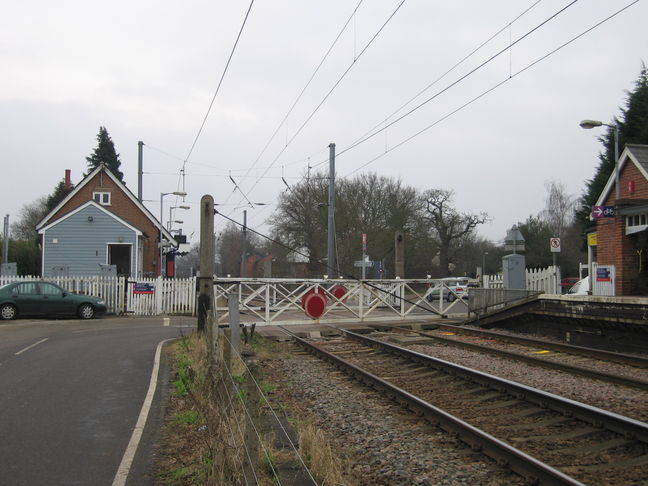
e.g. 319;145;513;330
36;165;178;278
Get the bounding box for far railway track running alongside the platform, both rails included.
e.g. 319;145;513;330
386;325;648;391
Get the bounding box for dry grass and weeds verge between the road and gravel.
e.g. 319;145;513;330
155;334;357;486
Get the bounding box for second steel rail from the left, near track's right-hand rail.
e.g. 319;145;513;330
338;328;648;443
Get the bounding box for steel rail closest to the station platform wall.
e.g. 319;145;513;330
426;324;648;368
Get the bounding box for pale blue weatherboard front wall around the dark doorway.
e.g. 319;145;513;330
43;206;137;277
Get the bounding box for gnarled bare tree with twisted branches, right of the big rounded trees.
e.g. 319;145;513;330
423;189;488;277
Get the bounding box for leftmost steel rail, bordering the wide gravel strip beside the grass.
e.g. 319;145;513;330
279;326;585;486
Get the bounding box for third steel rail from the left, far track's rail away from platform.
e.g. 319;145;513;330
393;327;648;391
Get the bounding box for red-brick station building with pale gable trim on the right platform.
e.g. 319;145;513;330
588;144;648;296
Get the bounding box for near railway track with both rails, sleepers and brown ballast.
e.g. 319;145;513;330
286;330;648;485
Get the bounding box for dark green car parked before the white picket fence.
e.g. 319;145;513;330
0;280;106;320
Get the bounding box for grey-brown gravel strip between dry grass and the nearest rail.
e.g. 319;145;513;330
263;343;527;486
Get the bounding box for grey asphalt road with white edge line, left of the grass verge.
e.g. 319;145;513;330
0;317;195;486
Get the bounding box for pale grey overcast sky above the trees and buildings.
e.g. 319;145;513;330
0;0;648;247
